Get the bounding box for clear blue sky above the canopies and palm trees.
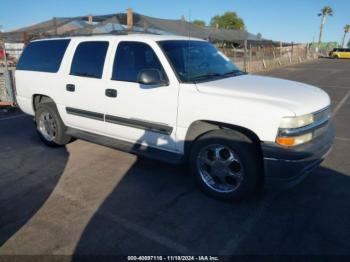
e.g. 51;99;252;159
0;0;350;43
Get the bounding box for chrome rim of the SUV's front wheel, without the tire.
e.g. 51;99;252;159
197;144;244;193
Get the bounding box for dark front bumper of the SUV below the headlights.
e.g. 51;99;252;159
262;123;335;187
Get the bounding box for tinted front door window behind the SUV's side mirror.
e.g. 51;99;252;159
112;42;167;82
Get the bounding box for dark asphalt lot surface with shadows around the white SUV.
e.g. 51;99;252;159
0;59;350;255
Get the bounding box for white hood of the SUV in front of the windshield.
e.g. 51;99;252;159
197;75;330;115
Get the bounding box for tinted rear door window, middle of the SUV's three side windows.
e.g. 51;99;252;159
70;41;109;78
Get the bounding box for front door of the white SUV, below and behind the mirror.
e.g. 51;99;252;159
104;41;179;151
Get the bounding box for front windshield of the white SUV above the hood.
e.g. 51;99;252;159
159;40;244;82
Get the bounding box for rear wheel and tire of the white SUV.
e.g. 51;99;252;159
35;103;72;147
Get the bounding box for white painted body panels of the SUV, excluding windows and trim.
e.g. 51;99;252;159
16;34;330;153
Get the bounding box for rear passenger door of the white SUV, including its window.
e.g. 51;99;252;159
60;41;109;133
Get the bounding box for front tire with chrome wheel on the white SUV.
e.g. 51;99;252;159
190;130;262;200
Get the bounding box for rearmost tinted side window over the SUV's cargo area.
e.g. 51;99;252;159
17;39;70;73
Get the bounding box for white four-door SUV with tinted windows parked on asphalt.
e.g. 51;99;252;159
15;35;334;199
